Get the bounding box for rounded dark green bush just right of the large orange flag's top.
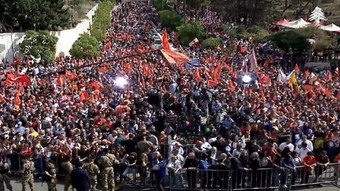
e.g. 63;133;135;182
177;22;205;45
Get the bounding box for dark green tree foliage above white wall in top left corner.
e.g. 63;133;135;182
0;0;70;32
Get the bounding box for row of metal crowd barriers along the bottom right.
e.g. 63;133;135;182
164;163;340;191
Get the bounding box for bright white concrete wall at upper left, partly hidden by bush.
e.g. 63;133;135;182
0;4;98;63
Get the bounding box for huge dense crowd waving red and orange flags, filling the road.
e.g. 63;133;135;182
0;0;340;191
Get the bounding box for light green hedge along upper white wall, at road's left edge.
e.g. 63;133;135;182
90;0;115;41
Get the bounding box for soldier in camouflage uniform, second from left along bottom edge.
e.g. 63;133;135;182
22;159;35;191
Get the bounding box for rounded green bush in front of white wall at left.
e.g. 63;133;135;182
20;31;58;62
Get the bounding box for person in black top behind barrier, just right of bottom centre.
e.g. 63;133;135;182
183;152;198;188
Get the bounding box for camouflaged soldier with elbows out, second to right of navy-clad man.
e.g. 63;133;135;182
99;154;119;191
